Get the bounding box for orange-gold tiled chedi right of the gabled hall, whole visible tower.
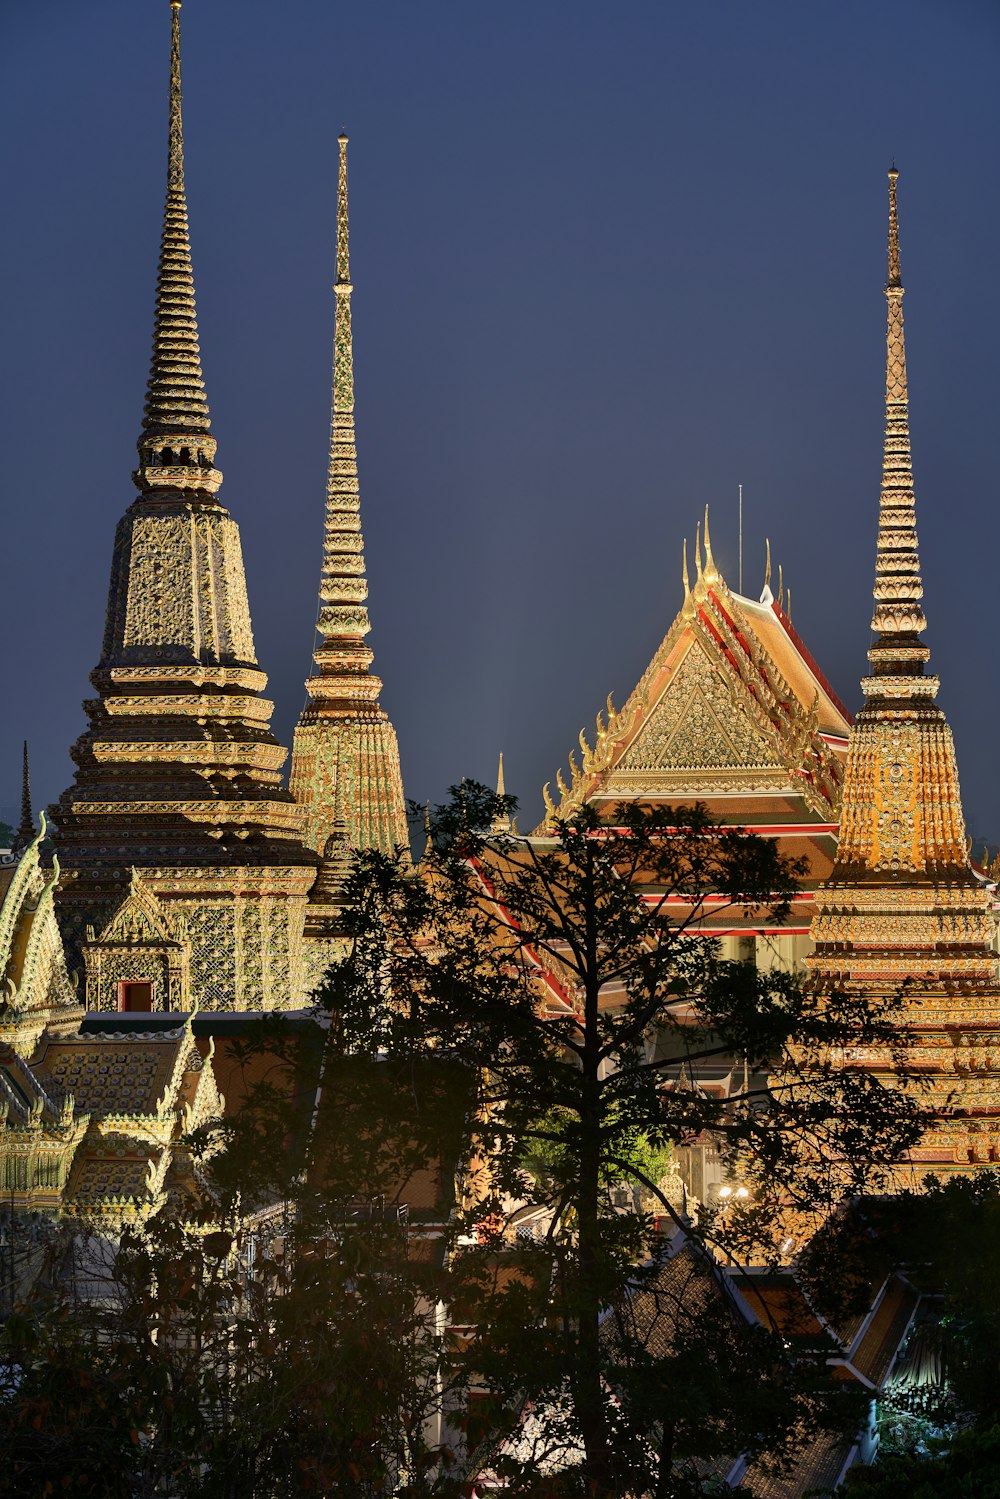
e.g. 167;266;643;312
808;168;1000;1174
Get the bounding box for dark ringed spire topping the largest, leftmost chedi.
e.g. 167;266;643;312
133;0;222;496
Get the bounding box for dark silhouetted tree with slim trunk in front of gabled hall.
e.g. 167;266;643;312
329;782;921;1499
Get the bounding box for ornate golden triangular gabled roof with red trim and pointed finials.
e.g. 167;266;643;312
543;525;850;823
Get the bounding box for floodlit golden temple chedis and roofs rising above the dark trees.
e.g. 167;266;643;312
0;0;1000;1219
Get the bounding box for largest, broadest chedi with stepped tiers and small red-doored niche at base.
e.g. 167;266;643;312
52;0;316;1009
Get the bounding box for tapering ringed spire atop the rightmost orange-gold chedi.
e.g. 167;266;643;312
862;166;937;697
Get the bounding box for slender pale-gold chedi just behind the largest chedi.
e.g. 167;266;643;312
291;135;406;853
